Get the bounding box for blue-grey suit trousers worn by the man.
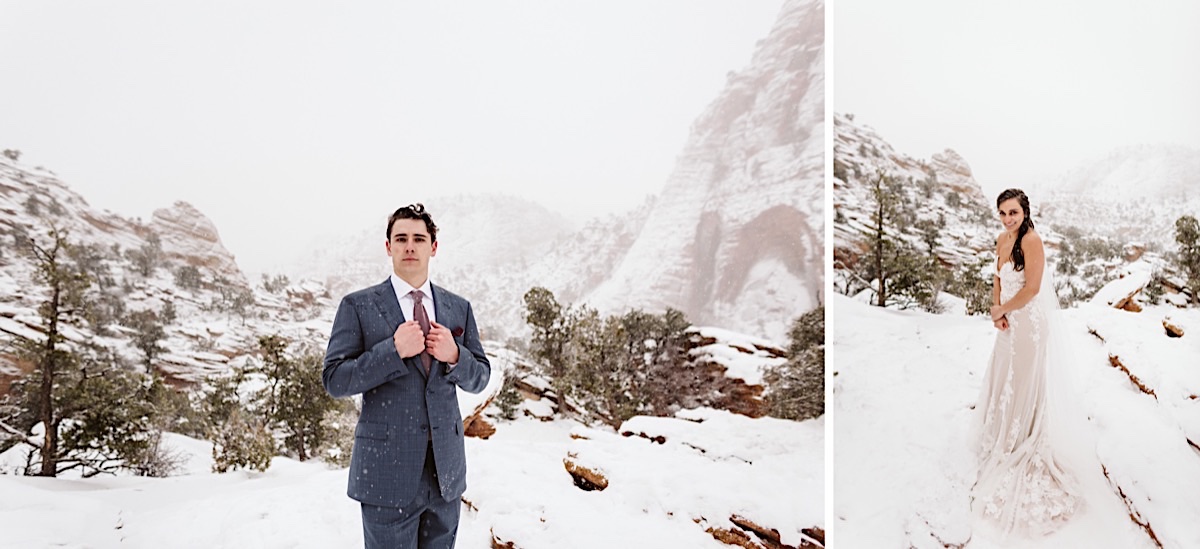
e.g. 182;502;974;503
360;442;462;549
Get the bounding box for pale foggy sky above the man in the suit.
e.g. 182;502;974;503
0;0;781;272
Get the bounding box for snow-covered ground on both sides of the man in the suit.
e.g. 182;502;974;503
0;409;824;549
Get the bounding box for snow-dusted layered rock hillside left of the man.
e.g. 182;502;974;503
0;152;336;392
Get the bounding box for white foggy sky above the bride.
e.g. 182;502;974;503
830;0;1200;200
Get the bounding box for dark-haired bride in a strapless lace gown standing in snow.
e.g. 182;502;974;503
971;189;1079;535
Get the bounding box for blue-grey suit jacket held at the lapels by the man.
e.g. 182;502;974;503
322;279;492;507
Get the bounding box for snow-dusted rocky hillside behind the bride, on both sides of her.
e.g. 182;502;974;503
833;114;1200;307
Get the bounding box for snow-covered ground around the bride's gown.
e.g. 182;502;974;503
830;294;1200;549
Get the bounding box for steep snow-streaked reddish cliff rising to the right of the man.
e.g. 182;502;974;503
588;1;824;339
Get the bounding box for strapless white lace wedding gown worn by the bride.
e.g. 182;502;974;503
971;261;1078;535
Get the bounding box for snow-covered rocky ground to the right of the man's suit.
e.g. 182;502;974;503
467;409;824;549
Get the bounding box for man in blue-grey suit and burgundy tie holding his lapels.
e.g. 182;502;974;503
322;204;492;549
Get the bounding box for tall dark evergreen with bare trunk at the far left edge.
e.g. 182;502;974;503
0;224;175;476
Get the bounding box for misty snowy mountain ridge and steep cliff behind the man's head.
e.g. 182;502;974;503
295;0;824;342
